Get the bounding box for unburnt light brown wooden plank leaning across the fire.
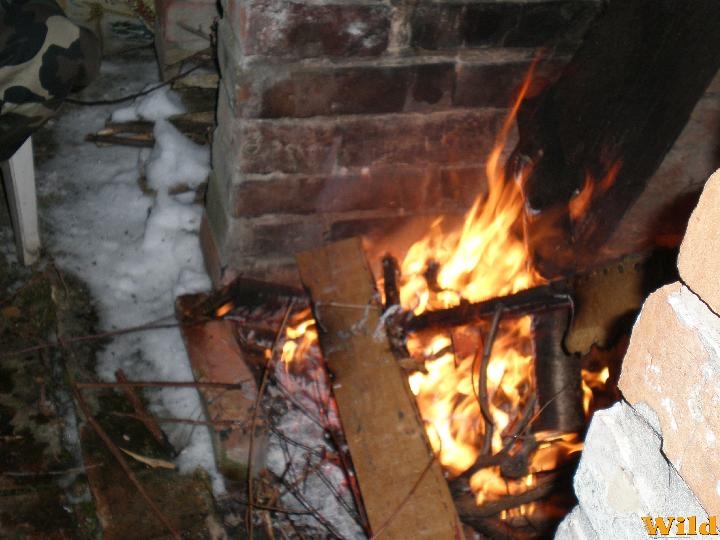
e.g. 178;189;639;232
297;239;463;540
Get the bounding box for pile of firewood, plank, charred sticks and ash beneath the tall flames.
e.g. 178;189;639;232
179;239;632;538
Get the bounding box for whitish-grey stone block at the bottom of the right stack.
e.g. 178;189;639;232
556;401;707;540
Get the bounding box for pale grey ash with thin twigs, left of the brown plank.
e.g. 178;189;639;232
263;332;367;539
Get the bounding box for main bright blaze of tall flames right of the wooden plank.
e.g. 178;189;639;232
401;60;547;504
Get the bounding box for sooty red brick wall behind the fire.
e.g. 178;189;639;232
203;0;600;280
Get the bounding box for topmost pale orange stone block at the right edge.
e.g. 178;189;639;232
678;170;720;314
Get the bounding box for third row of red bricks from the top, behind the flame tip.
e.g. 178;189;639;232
225;109;504;176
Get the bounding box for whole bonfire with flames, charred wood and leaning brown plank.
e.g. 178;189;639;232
173;52;632;537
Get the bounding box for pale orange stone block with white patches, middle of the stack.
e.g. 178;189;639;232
618;283;720;515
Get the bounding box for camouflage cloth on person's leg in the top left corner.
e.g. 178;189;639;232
0;0;101;161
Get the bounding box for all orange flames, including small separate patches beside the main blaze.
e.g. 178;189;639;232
282;57;608;513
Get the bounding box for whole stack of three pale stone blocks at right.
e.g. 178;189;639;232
556;170;720;538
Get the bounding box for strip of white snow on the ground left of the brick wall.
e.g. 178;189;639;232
29;54;224;493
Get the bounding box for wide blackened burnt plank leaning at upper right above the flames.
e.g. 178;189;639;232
513;0;720;277
